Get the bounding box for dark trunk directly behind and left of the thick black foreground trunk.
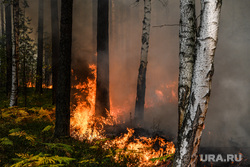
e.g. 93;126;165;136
51;0;60;104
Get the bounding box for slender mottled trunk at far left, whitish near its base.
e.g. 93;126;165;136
10;0;19;107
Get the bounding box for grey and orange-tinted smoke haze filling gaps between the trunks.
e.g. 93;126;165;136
24;0;250;146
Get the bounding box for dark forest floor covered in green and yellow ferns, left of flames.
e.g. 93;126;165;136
0;88;172;167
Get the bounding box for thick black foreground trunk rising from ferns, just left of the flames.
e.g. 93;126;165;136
54;0;73;137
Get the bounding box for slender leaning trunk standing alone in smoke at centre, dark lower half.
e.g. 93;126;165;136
135;0;151;125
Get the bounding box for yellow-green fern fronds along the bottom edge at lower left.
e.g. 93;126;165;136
11;153;75;167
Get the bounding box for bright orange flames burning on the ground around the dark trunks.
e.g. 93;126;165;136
71;65;175;166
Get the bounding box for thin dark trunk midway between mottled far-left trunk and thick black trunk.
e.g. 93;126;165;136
36;0;44;94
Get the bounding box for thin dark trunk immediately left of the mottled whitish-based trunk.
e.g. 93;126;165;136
5;0;12;96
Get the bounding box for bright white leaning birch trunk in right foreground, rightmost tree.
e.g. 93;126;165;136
174;0;222;167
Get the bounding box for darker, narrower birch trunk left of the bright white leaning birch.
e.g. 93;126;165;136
175;0;197;164
